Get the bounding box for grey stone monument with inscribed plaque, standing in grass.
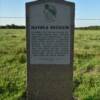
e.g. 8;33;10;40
26;0;75;100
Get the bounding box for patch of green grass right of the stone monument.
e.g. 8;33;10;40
74;30;100;100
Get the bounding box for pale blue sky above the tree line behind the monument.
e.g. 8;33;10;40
0;0;100;26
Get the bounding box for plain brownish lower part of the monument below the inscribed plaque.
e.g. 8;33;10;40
27;65;72;100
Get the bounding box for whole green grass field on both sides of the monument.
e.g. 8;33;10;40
0;29;100;100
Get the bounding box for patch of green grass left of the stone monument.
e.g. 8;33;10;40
0;29;26;100
